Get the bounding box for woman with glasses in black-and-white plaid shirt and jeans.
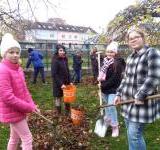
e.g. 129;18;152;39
114;28;160;150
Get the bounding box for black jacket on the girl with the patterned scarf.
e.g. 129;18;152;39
101;58;125;94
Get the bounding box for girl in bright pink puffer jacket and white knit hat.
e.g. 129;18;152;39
0;33;39;150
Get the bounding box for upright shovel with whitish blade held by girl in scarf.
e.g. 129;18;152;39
94;52;108;137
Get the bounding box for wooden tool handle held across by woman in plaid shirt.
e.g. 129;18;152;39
98;94;160;108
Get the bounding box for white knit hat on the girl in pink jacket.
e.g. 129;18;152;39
0;33;21;57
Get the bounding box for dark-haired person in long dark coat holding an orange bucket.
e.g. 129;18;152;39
51;45;72;115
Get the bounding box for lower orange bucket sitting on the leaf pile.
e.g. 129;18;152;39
71;108;84;125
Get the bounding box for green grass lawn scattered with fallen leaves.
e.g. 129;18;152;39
0;79;160;150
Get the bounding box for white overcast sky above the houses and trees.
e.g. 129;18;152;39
0;0;138;32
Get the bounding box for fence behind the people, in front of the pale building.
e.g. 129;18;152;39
20;42;130;74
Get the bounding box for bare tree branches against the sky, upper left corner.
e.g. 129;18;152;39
0;0;57;35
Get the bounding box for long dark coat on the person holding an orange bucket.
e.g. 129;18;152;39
51;56;70;97
